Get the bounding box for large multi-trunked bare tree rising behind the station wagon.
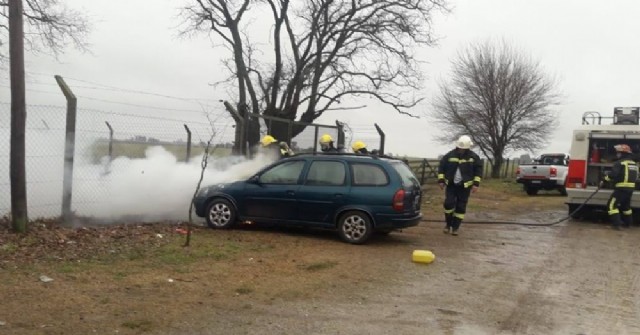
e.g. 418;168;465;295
183;0;449;150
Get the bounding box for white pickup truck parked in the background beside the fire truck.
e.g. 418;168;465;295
516;153;569;195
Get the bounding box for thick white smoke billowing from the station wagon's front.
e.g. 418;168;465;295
73;146;274;221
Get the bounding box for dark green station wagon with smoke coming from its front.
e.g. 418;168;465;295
194;154;422;244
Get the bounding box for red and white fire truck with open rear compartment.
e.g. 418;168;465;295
566;107;640;218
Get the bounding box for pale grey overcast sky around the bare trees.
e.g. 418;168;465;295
0;0;640;157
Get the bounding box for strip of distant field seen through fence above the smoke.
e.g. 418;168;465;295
87;141;231;163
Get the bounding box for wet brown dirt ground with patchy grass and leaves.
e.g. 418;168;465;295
0;182;640;335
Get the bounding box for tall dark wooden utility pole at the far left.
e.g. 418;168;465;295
9;0;29;233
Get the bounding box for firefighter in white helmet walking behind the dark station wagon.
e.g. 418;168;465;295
438;135;482;235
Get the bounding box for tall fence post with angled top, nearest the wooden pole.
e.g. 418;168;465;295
55;75;78;226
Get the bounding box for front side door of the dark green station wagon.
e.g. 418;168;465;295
243;160;305;221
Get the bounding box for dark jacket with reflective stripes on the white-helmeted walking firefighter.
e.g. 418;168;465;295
438;149;482;187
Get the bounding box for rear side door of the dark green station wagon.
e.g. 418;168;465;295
297;160;349;225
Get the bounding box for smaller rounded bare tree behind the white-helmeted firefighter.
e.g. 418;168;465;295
429;41;560;177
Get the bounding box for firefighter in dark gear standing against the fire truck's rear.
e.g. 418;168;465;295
601;144;638;230
